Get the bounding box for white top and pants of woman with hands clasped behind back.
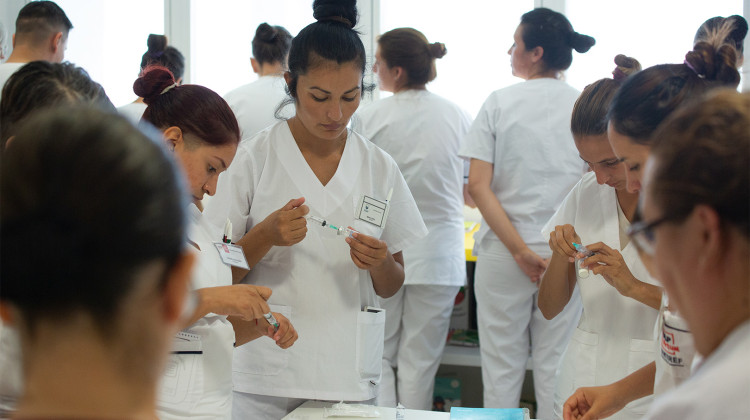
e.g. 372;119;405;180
460;78;583;419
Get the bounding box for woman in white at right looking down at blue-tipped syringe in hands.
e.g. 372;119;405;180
539;55;661;419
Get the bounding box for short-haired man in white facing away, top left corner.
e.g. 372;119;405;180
0;1;73;88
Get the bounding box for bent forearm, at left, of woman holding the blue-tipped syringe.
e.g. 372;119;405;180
538;254;576;319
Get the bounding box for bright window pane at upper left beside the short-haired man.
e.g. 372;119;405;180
55;0;164;106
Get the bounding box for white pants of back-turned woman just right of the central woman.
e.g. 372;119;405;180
376;284;460;410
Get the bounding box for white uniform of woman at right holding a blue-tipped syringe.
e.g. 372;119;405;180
542;172;658;420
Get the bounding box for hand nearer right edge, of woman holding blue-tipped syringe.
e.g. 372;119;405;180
581;242;640;297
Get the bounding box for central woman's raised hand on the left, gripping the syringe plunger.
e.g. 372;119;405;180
261;197;310;246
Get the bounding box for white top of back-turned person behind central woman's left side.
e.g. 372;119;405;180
224;76;294;140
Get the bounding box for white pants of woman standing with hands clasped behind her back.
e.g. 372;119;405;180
474;244;581;420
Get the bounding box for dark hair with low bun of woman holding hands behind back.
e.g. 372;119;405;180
521;7;596;70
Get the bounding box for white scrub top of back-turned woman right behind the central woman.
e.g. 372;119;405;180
352;89;471;286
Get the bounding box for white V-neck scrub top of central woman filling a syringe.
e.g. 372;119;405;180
206;121;427;401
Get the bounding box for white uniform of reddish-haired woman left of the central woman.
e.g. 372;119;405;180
157;204;238;420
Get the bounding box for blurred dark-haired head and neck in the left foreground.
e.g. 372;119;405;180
0;107;194;419
